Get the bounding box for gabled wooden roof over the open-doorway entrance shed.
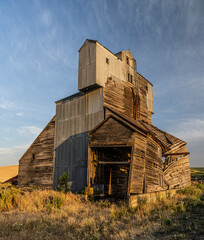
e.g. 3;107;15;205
89;107;186;151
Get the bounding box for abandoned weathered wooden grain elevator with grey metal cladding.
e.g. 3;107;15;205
18;39;191;198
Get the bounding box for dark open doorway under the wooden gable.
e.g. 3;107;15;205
94;147;131;198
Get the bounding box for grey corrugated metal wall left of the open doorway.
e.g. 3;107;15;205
54;88;103;192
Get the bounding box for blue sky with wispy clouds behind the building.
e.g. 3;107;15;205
0;0;204;166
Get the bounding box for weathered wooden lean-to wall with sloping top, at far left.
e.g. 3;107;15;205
18;117;55;188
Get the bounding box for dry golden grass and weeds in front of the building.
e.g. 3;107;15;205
0;184;204;240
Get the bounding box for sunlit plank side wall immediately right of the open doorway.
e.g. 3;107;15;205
130;132;164;194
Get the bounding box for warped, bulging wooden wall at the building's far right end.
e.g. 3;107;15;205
164;145;191;189
